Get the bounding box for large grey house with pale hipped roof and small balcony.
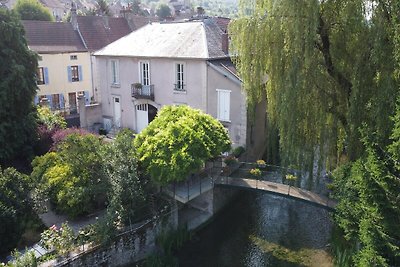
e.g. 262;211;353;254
95;19;265;153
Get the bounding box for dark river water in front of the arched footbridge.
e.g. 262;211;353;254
178;191;333;267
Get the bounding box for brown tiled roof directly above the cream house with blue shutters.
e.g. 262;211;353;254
22;20;87;53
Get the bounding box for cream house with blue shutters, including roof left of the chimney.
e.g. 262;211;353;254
22;21;93;114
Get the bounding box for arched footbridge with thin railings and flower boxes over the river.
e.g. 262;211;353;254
163;162;337;210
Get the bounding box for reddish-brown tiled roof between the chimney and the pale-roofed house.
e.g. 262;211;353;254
77;16;131;51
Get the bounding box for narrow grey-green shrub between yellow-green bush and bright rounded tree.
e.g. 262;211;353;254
104;129;146;223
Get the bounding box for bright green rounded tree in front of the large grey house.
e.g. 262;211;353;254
134;106;230;184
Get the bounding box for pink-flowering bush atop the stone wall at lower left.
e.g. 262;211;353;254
41;223;75;254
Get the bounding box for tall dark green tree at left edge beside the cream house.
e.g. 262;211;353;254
0;8;37;163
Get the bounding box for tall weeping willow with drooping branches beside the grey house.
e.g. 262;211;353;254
230;0;398;171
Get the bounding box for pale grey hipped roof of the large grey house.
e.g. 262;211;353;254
95;20;228;59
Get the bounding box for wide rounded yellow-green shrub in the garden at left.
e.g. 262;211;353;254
31;134;108;217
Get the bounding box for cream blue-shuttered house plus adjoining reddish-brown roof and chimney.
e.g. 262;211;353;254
23;6;131;115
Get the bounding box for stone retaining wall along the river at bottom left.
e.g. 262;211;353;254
55;208;178;267
